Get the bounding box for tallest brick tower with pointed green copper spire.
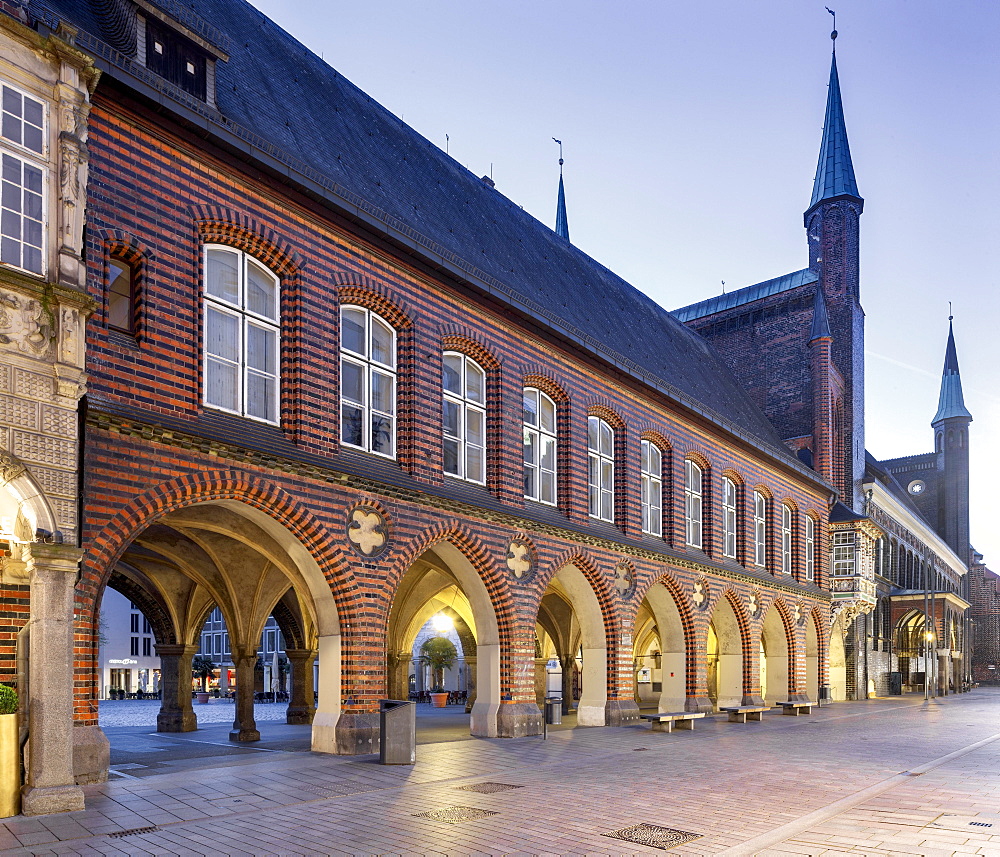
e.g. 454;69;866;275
804;30;865;511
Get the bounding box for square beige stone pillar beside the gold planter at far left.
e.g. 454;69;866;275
21;543;83;815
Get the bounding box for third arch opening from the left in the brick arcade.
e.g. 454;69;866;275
535;565;608;726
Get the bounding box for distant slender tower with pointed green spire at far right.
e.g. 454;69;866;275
931;317;972;564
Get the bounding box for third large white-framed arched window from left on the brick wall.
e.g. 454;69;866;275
441;351;486;485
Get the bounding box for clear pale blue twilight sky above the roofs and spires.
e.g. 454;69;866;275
253;0;1000;571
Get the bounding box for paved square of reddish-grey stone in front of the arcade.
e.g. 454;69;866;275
0;689;1000;857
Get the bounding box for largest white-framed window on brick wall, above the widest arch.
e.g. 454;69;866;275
204;244;280;424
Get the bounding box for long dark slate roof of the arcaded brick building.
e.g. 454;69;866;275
32;0;818;478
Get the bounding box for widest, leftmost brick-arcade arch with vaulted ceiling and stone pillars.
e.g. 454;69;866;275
97;500;340;752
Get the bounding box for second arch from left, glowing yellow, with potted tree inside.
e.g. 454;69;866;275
386;542;500;741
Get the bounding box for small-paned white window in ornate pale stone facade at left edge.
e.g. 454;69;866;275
0;83;46;274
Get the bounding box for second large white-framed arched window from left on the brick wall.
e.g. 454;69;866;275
340;306;396;458
